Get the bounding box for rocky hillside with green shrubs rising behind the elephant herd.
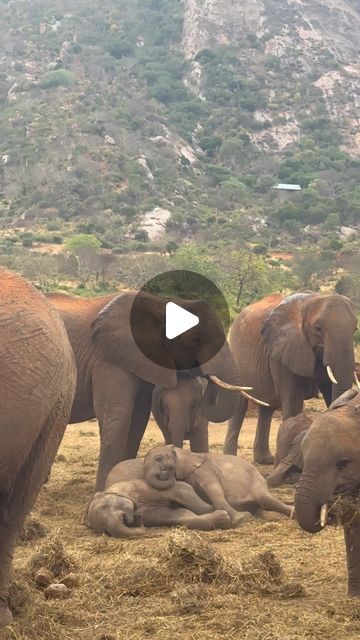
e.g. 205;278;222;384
0;0;360;252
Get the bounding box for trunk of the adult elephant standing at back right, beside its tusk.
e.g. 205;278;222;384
323;338;355;402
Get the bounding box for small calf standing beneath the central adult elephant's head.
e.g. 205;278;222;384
152;374;209;453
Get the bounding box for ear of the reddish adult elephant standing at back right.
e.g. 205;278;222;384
261;293;315;378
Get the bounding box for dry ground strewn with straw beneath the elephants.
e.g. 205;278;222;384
4;402;360;640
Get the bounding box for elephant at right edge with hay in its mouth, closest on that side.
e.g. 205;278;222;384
295;390;360;597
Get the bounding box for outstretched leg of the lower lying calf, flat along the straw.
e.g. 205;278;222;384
142;505;231;531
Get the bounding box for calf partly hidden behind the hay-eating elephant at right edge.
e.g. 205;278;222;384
267;412;312;487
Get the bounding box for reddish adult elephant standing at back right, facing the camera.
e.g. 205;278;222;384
224;292;357;464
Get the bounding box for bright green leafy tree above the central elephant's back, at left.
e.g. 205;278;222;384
64;233;101;287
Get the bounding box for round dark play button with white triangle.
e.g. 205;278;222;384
130;269;230;375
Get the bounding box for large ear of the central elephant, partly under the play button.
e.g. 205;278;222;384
91;293;177;387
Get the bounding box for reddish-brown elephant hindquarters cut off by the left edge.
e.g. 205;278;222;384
0;268;76;627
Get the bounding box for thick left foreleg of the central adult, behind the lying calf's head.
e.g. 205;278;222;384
92;363;139;491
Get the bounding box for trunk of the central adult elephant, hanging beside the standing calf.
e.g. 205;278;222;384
201;342;242;422
